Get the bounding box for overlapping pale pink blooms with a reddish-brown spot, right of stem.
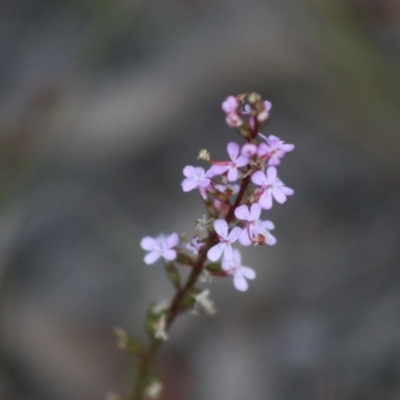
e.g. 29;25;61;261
235;203;276;246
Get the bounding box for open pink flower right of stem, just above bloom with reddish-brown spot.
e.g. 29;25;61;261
251;167;294;210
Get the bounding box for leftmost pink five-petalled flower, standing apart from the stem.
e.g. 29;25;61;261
140;233;179;264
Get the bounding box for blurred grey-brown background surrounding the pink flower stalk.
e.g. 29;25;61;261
0;0;400;400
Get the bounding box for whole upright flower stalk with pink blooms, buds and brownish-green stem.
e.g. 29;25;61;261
120;93;294;400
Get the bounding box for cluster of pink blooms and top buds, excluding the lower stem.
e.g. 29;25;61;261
141;93;294;298
